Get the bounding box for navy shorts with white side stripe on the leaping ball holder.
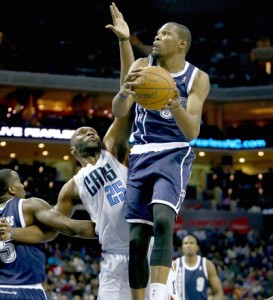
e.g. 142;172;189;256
125;147;195;225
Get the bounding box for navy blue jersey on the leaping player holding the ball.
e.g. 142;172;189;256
133;57;198;145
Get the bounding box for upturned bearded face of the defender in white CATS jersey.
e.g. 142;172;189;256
74;127;101;157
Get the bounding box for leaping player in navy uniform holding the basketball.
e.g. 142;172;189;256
112;5;210;300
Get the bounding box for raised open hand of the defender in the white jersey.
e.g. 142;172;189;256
105;2;130;39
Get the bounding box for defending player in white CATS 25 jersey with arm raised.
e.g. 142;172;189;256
0;4;133;300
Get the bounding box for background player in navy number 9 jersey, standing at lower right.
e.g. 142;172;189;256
173;235;224;300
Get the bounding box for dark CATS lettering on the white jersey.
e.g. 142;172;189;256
84;163;117;197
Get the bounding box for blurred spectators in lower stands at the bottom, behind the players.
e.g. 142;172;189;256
38;224;273;300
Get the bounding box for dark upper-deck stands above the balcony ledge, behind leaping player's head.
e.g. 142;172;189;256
0;1;273;87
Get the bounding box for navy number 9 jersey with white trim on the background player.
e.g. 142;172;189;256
175;255;209;300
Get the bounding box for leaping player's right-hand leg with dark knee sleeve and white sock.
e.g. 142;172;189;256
150;204;176;300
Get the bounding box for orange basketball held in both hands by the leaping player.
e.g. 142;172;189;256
132;66;175;110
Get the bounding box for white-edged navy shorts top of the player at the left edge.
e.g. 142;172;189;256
0;284;47;300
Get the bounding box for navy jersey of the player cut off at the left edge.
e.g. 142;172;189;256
0;198;46;285
